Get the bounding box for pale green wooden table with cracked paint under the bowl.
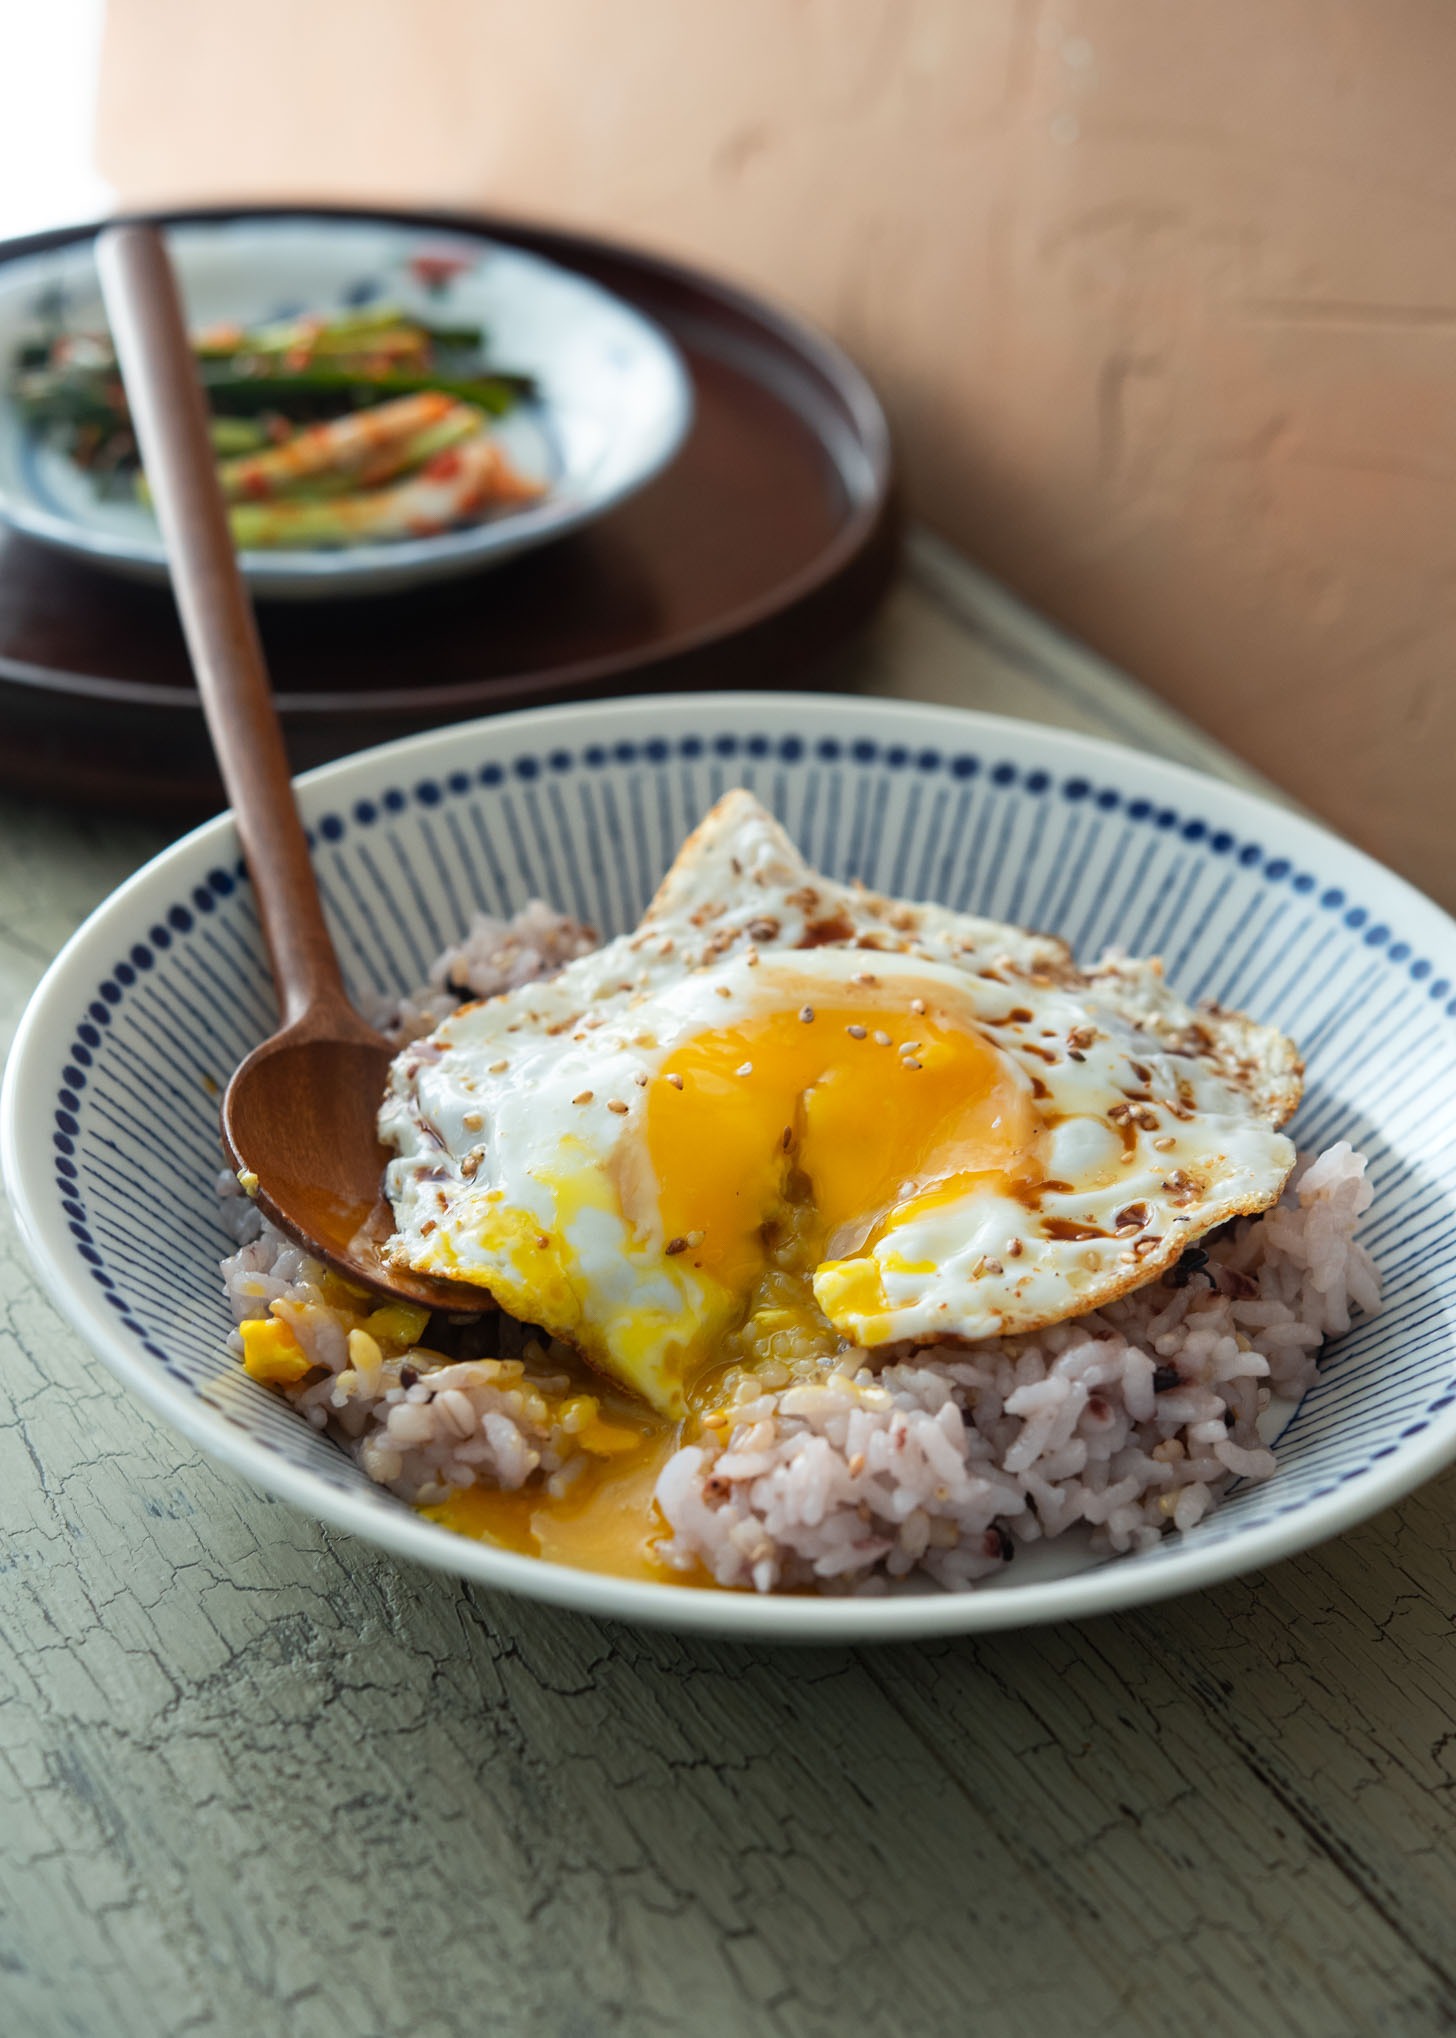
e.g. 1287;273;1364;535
0;542;1456;2038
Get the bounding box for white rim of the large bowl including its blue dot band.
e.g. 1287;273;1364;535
0;693;1456;1643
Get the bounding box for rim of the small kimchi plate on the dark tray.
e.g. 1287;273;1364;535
0;206;695;597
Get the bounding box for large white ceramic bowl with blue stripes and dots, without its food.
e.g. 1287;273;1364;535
0;695;1456;1643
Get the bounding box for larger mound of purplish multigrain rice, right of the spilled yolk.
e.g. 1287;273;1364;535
657;1141;1381;1592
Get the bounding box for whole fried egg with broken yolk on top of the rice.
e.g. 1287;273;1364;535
379;791;1301;1414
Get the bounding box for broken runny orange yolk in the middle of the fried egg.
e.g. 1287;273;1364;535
646;972;1042;1300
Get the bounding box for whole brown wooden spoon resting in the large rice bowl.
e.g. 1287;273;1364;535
96;224;493;1312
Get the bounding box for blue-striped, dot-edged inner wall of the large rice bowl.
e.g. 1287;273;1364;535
51;741;1456;1563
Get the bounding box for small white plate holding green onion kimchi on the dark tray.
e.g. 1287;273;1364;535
0;214;693;597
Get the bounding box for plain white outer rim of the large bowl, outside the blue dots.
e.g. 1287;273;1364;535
0;693;1456;1643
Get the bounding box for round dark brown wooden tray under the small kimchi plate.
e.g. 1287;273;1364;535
0;206;897;815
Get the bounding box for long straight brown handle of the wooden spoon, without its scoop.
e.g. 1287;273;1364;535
96;222;347;1023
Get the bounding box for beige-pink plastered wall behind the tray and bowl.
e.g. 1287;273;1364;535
98;0;1456;905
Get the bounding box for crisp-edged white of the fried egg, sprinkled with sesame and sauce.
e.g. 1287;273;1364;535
379;791;1301;1410
